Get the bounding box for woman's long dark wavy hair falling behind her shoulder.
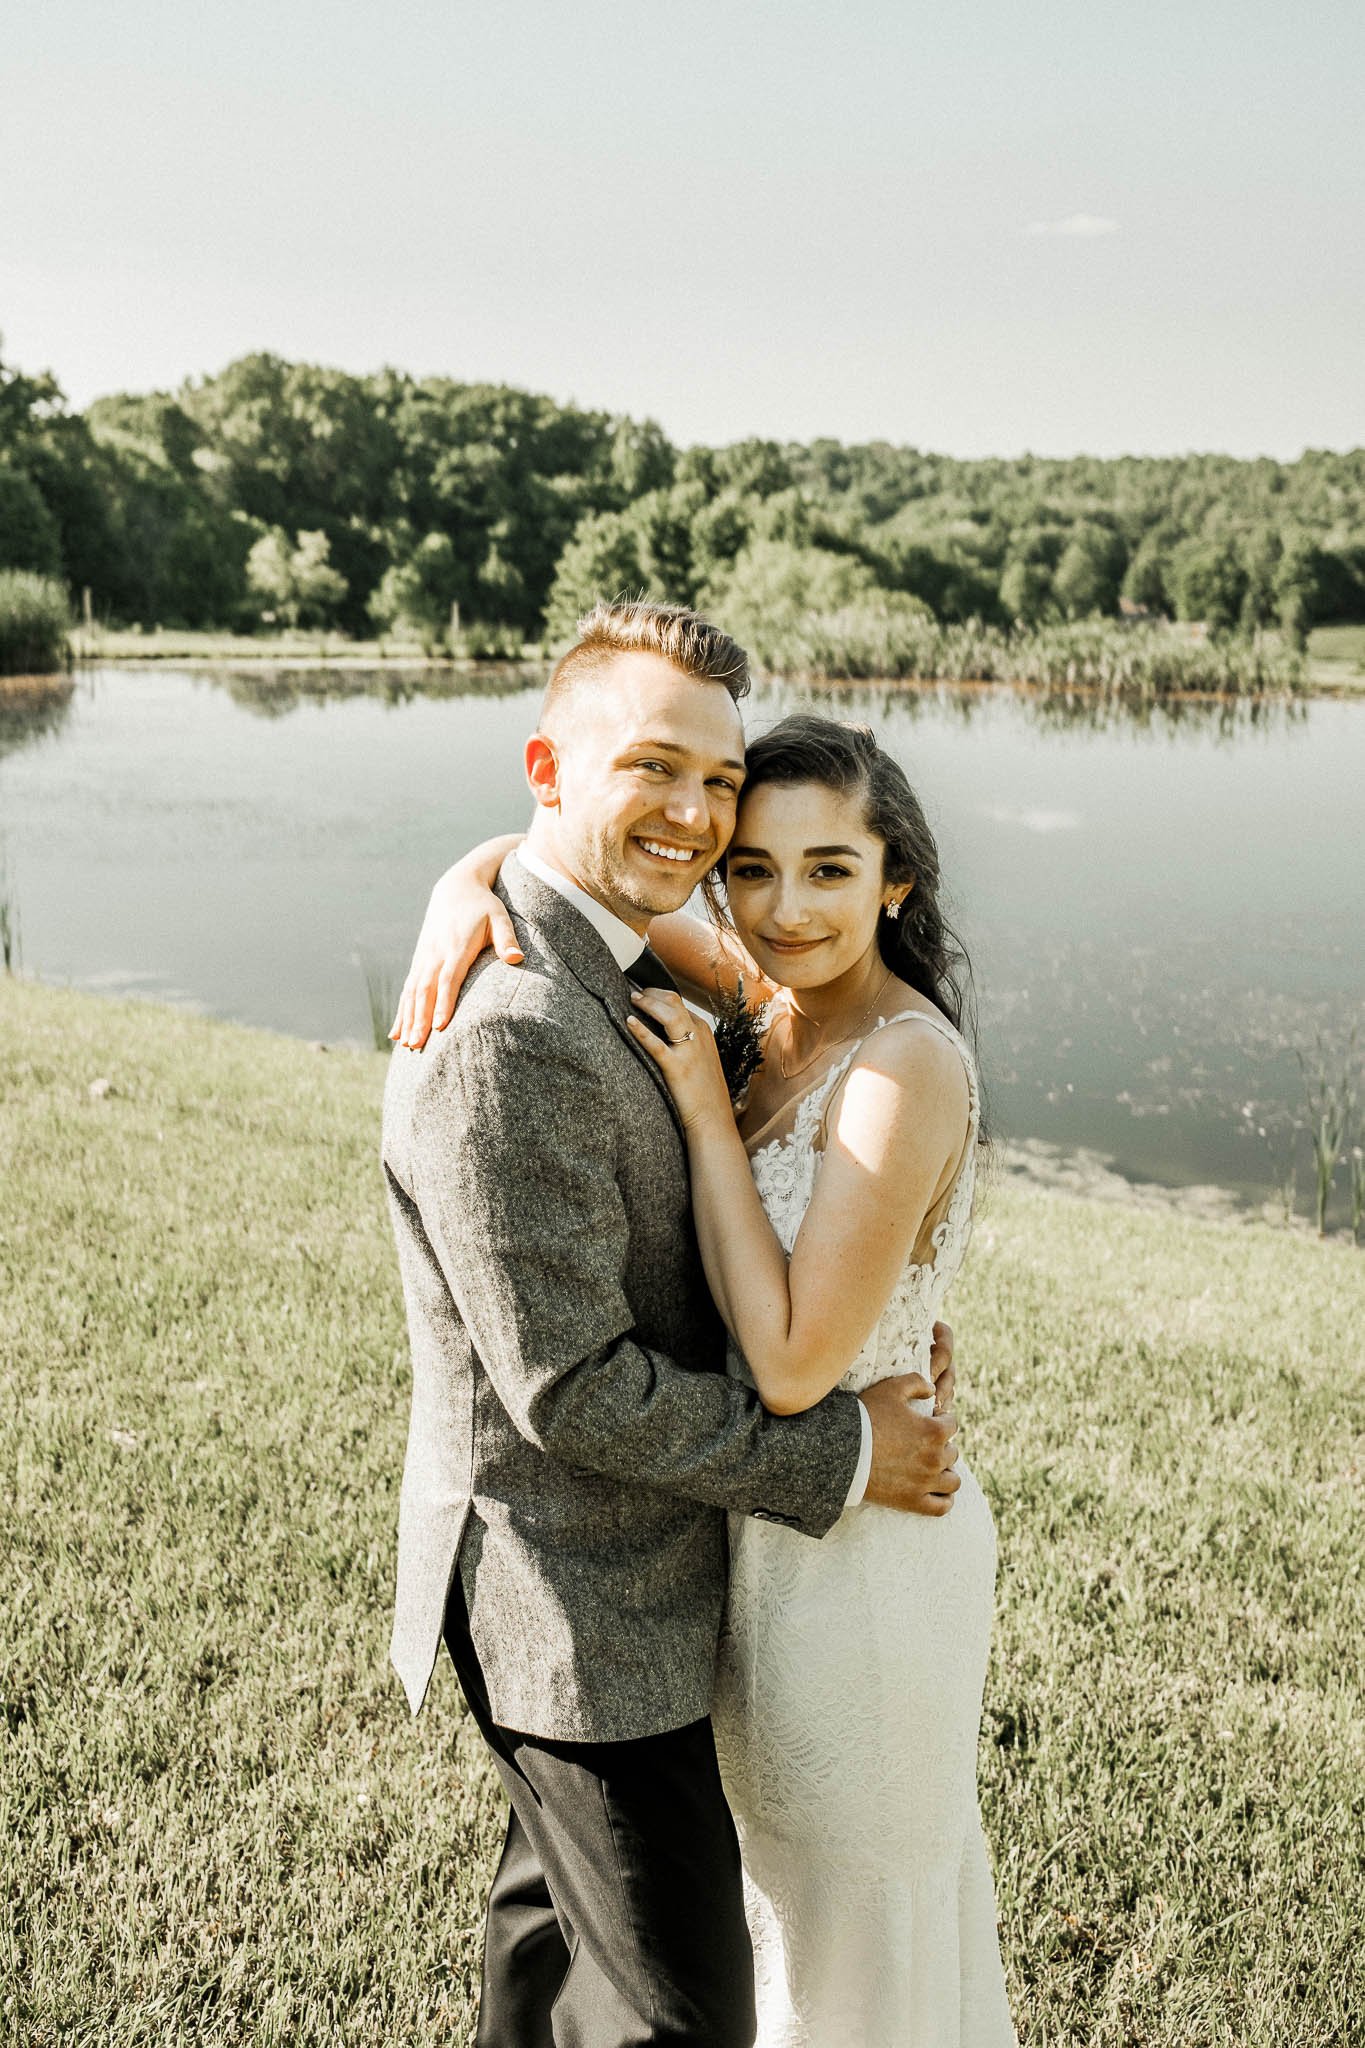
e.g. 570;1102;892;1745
704;713;984;1128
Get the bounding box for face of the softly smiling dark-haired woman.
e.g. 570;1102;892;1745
724;782;905;989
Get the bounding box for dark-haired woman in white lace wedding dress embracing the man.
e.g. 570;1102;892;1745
395;717;1015;2048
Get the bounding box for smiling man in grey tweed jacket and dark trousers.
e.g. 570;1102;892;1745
383;604;958;2048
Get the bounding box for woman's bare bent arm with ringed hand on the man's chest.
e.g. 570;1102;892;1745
634;989;970;1415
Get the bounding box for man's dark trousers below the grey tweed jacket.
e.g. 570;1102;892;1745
446;1573;755;2048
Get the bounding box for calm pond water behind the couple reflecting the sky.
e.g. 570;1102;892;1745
0;666;1365;1206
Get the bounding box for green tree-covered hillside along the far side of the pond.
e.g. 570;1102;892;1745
0;339;1365;645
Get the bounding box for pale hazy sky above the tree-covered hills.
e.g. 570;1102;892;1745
0;0;1365;457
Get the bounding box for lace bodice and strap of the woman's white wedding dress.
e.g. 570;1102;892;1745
749;1010;980;1393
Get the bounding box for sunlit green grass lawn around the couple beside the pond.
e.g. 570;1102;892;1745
0;981;1365;2048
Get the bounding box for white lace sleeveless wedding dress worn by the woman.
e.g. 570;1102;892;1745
712;1010;1015;2048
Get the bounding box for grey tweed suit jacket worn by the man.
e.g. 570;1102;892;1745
383;862;862;1741
